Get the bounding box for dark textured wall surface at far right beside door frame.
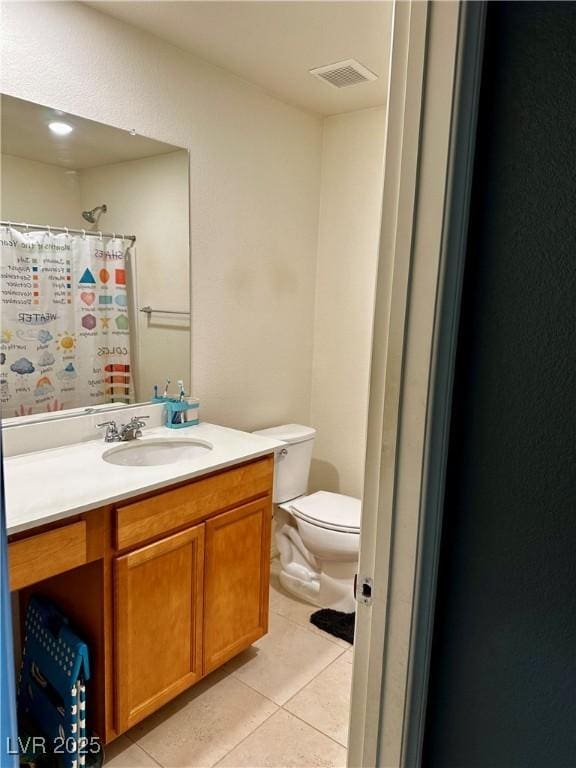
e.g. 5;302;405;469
424;3;576;768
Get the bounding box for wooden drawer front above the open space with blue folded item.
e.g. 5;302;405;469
8;521;87;591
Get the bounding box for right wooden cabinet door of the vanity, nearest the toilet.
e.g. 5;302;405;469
203;497;272;673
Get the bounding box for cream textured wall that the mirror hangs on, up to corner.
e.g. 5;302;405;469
1;2;322;429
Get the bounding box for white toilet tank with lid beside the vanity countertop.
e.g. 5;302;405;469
254;424;316;504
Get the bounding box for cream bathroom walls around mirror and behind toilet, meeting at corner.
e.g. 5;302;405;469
1;2;385;496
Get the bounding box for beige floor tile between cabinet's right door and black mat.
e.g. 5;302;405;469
225;614;343;704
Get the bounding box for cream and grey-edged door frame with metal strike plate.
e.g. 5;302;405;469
348;0;485;768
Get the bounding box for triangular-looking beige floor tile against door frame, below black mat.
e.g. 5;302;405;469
284;653;352;746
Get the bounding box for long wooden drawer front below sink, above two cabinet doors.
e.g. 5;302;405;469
116;456;274;550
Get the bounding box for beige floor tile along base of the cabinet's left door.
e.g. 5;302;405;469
130;672;277;768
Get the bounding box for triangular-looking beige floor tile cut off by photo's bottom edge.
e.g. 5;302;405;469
218;710;346;768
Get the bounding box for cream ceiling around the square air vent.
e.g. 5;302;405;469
86;0;392;115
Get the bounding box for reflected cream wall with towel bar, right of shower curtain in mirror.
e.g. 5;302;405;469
79;150;190;400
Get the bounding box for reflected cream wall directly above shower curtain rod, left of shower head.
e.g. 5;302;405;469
0;155;86;227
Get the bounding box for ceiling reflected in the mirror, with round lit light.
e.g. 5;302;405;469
0;95;180;171
